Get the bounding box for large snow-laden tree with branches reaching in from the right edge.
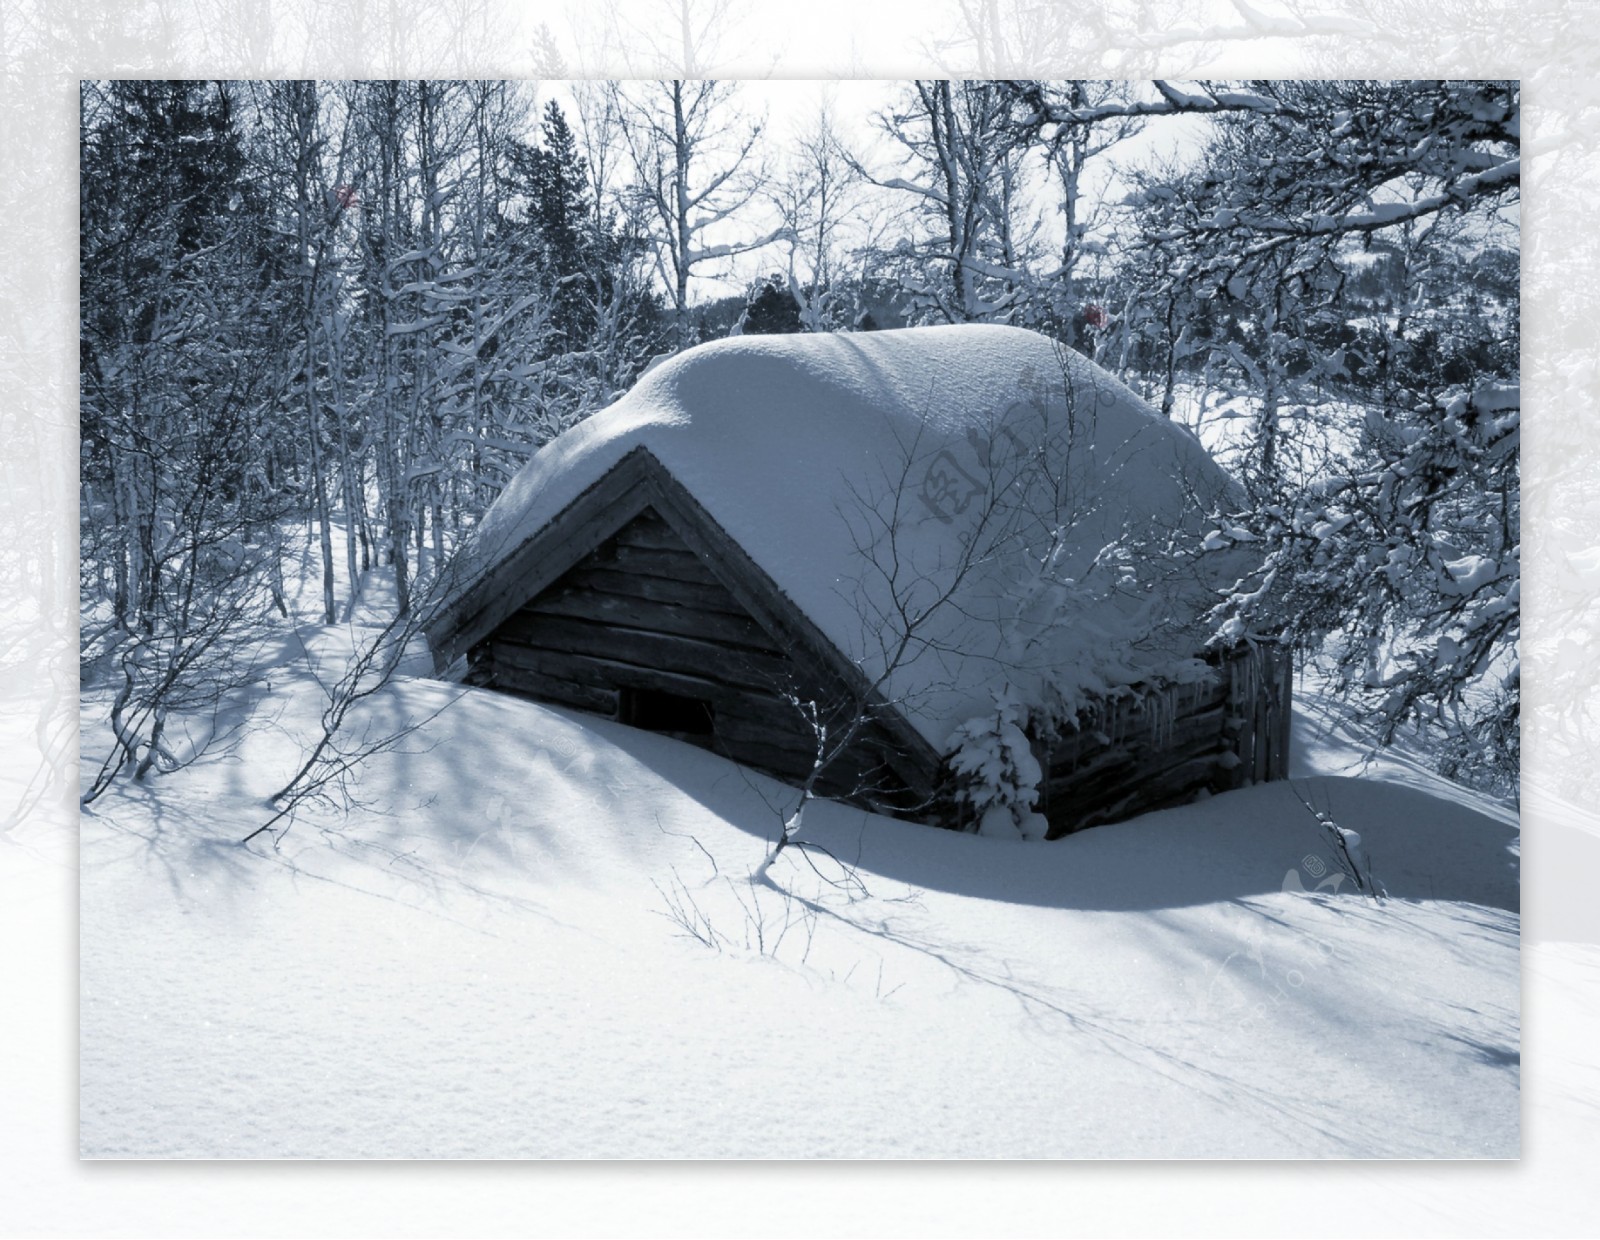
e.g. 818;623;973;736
1138;82;1522;789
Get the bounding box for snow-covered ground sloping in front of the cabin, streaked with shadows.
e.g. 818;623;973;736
80;576;1520;1158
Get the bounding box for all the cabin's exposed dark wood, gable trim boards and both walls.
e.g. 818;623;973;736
457;480;1290;837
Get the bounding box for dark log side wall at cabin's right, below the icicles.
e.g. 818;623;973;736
1035;645;1293;838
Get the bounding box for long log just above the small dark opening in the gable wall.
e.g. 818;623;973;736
494;611;794;690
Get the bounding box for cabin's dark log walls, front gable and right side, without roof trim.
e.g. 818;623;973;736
467;509;1291;837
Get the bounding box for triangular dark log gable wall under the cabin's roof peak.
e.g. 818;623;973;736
467;509;925;811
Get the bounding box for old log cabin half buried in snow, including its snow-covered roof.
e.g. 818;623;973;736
427;326;1288;835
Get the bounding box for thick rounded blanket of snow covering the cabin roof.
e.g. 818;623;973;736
441;325;1234;752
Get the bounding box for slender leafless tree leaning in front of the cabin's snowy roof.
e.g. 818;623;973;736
757;349;1219;878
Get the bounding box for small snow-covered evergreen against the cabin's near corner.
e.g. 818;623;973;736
949;685;1048;840
